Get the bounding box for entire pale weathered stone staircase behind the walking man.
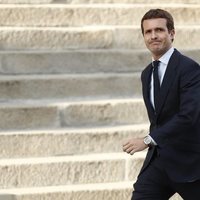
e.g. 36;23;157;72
0;0;200;200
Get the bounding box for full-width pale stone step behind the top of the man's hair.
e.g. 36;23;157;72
0;3;200;27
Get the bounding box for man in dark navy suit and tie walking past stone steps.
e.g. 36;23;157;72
123;9;200;200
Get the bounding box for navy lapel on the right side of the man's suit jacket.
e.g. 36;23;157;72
158;49;180;114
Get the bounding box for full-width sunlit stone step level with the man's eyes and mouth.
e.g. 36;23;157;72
0;25;200;50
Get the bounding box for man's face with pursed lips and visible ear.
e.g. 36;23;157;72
143;18;175;59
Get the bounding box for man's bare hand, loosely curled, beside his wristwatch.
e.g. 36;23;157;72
123;138;148;155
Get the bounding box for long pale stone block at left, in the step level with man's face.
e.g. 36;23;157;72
0;28;113;50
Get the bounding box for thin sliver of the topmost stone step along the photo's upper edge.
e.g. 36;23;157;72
0;0;199;4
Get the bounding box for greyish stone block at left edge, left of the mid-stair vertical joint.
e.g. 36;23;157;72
0;105;59;130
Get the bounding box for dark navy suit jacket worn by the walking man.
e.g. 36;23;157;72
141;49;200;182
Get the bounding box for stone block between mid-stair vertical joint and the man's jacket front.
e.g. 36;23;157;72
61;99;148;127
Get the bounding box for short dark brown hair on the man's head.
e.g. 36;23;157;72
141;9;174;35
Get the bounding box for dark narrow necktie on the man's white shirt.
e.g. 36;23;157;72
153;60;160;110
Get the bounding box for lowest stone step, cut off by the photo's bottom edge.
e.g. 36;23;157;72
0;181;182;200
